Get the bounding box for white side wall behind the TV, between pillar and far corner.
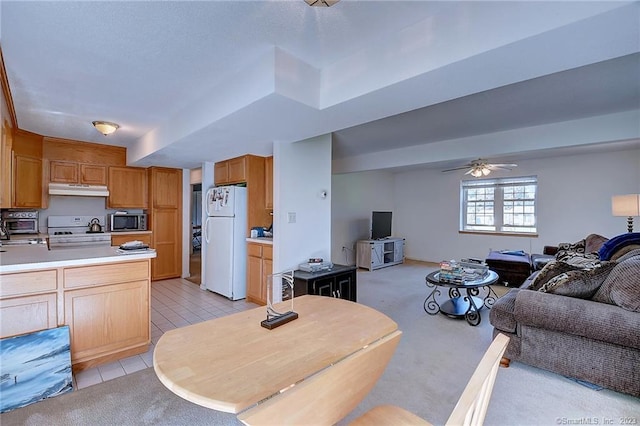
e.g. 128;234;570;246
331;171;396;265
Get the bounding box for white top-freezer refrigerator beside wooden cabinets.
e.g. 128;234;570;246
202;186;248;300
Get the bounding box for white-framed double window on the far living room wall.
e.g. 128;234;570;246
460;176;538;234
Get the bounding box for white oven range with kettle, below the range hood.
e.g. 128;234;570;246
47;215;111;249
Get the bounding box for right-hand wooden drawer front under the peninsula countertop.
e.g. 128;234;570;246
64;260;149;288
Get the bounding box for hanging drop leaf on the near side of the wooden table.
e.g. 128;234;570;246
238;330;402;425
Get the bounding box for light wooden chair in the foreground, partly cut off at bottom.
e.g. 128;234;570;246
350;334;509;426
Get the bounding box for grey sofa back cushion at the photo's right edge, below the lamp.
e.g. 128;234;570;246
593;256;640;312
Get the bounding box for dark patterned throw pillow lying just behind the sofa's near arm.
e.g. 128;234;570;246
539;262;616;299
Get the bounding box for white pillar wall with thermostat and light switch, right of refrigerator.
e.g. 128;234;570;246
273;135;333;272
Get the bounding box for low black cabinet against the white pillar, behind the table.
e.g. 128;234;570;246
293;265;357;302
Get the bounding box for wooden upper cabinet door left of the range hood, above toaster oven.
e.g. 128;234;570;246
13;155;42;208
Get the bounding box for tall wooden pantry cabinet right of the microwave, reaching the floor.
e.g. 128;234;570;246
148;167;182;280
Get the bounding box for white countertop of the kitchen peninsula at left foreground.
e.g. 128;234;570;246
0;244;156;273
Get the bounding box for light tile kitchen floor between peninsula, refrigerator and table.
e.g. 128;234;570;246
73;279;258;389
